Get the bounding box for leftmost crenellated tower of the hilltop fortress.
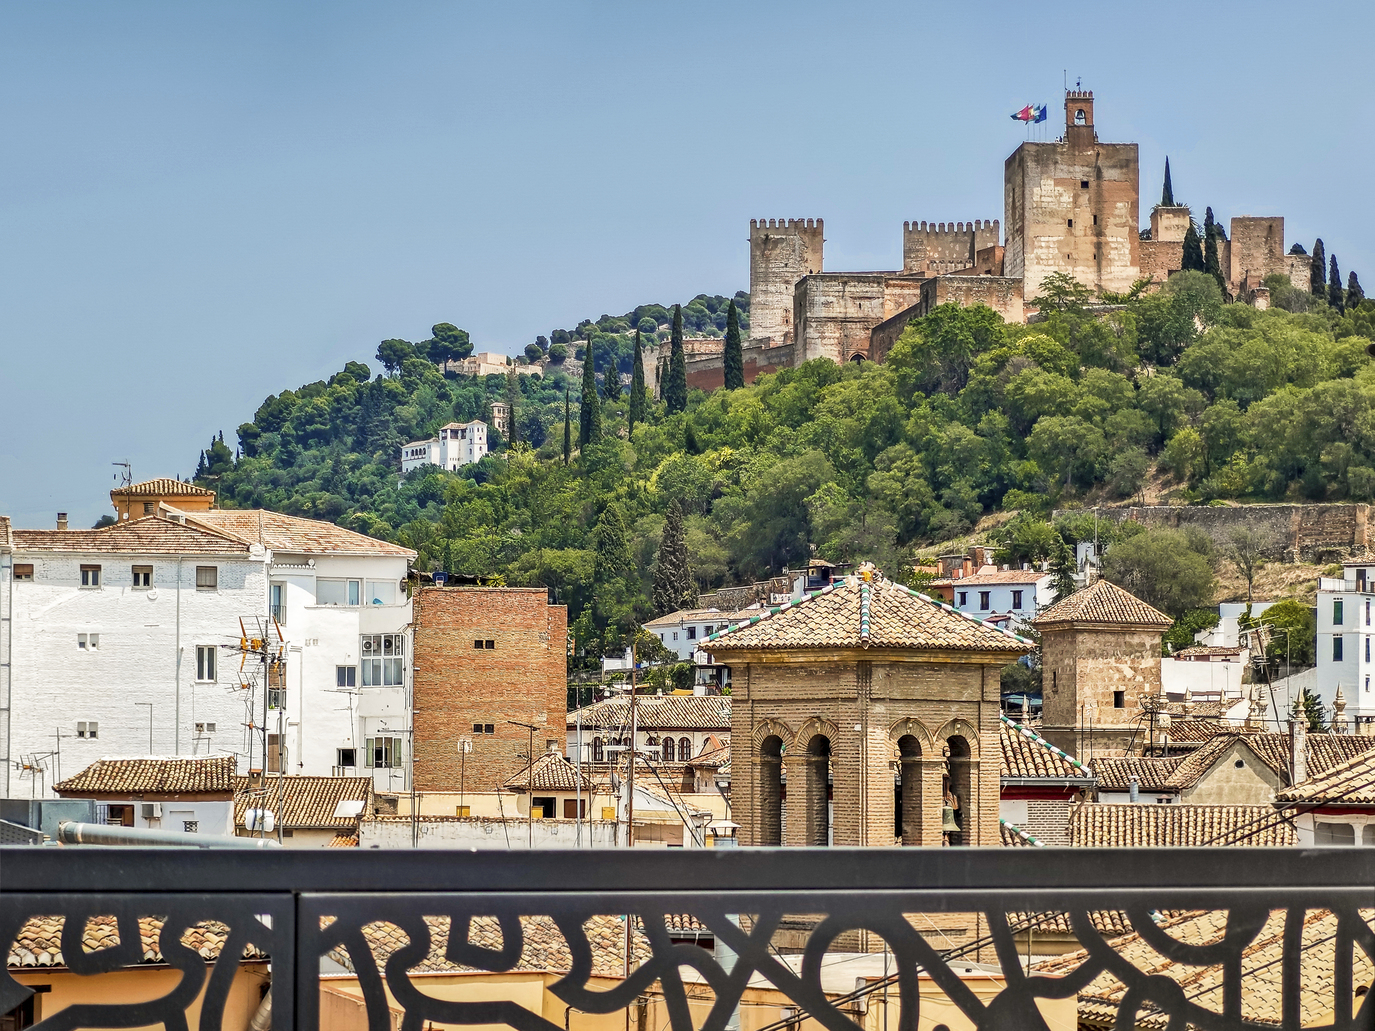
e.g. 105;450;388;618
749;219;825;346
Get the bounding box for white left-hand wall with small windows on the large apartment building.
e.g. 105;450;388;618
10;551;267;797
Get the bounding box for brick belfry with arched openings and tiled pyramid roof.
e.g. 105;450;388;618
707;566;1031;847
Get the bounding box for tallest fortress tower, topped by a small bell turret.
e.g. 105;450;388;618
1002;89;1141;301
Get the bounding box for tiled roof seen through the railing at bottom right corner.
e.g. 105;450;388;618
1034;910;1375;1028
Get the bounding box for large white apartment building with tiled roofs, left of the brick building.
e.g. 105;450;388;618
0;486;414;796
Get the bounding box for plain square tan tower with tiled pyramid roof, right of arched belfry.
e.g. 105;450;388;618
1033;580;1174;763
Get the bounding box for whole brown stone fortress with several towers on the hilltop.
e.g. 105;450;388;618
660;89;1310;390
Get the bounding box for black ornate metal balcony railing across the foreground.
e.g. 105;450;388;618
0;847;1375;1031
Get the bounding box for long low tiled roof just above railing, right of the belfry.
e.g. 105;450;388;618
1068;803;1298;848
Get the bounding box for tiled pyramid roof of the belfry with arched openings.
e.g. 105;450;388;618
703;575;1033;654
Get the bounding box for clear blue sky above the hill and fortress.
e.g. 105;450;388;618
0;0;1375;526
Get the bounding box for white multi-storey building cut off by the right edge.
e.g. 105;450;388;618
1317;561;1375;720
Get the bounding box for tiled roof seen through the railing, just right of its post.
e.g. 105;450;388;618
331;916;650;977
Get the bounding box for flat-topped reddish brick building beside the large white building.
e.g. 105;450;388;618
414;587;568;790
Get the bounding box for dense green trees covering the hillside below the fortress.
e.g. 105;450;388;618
198;272;1375;662
